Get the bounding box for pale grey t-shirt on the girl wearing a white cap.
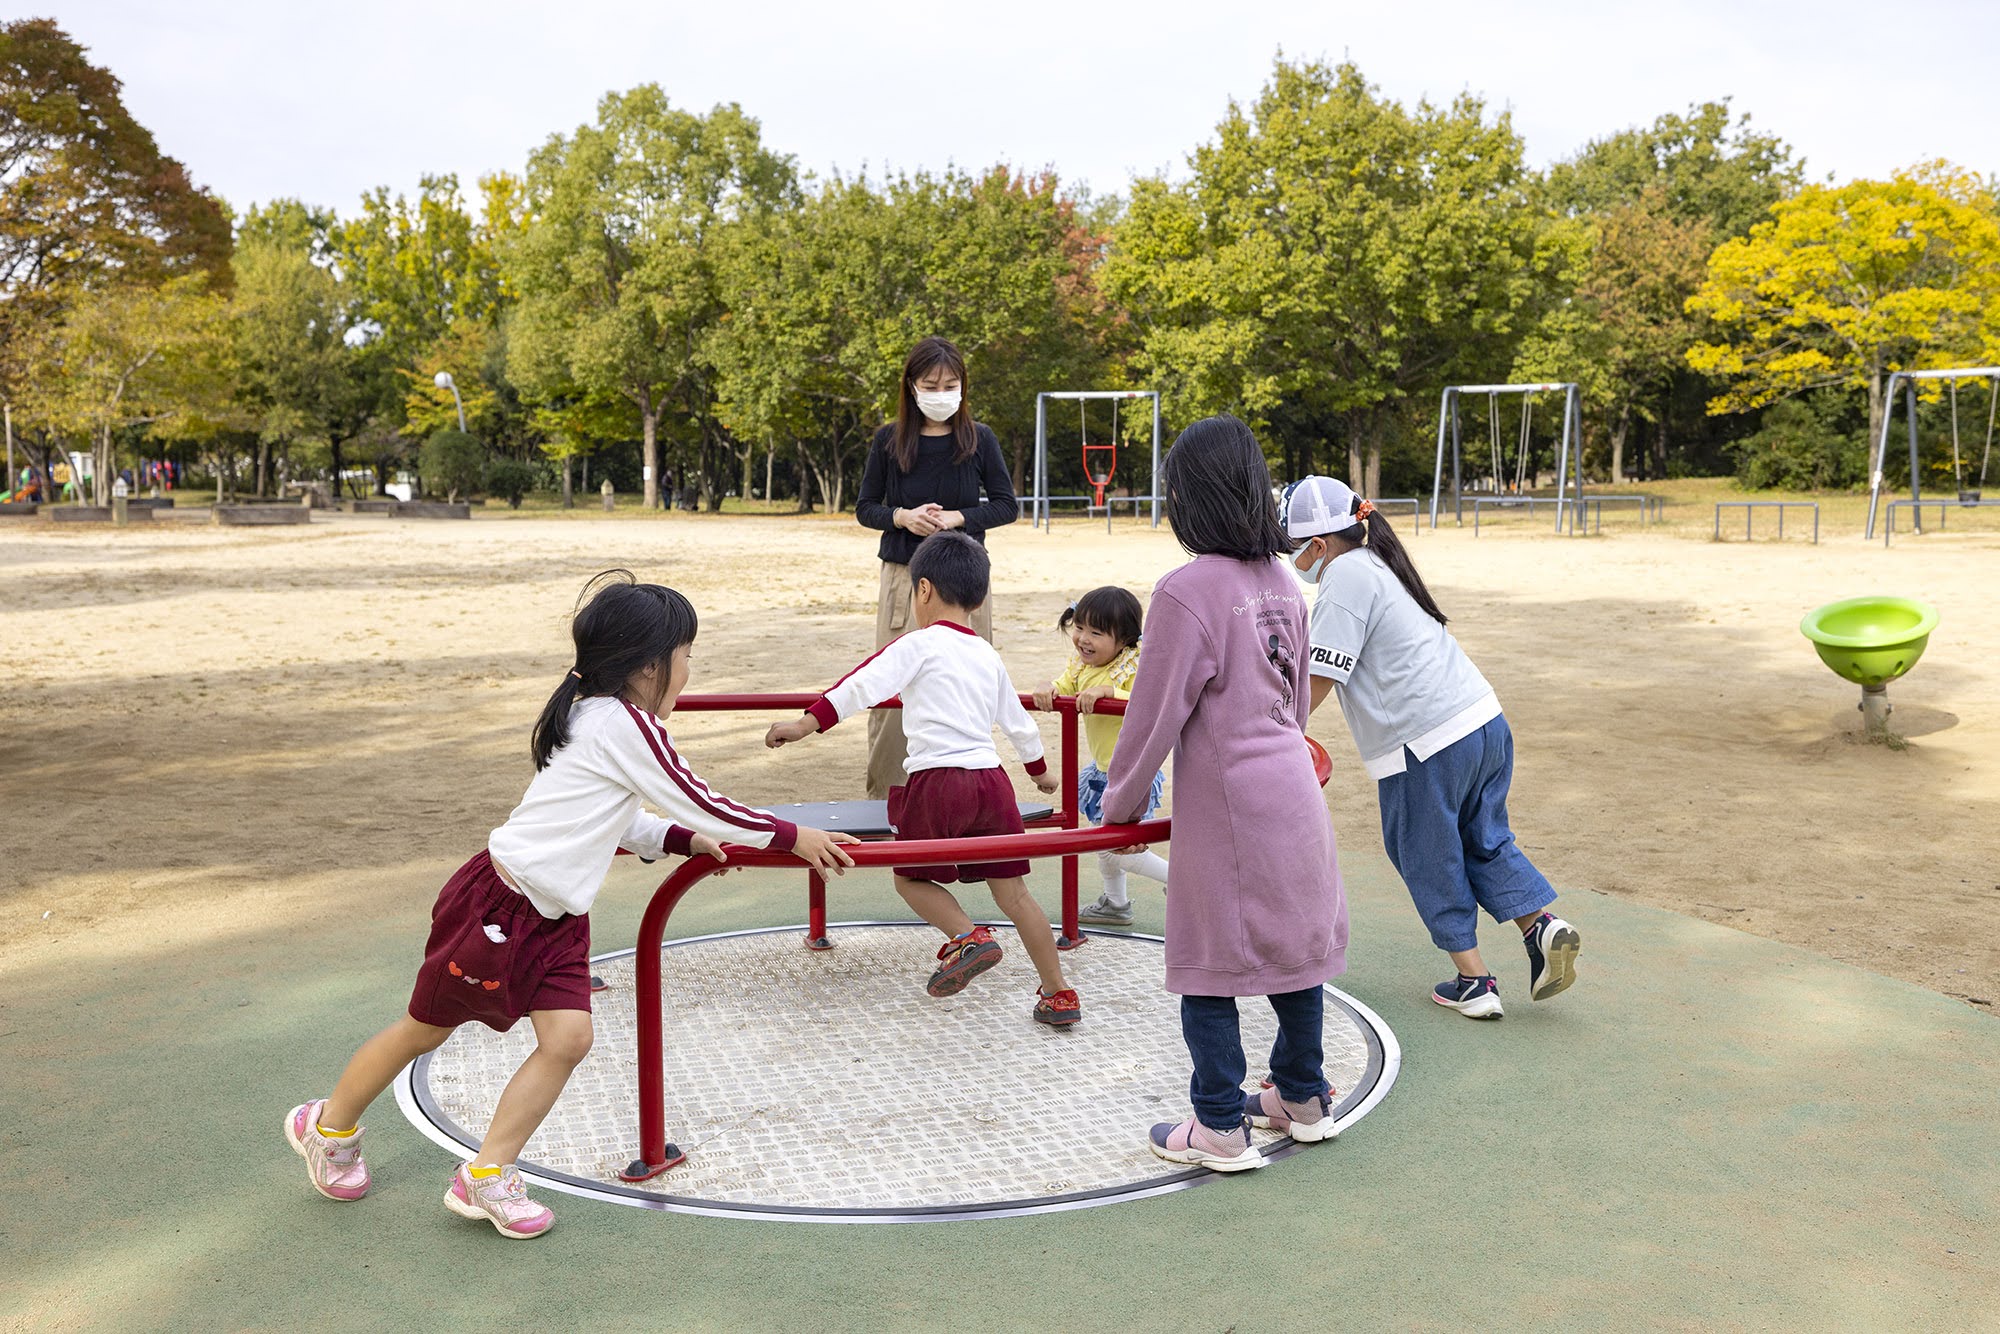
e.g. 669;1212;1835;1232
1308;546;1500;778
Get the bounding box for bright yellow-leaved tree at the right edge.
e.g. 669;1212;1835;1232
1688;162;2000;440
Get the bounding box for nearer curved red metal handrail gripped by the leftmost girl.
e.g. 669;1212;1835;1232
618;816;1174;1182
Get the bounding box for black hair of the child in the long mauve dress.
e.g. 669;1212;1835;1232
1160;414;1292;560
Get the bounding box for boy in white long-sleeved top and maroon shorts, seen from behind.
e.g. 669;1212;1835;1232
764;532;1082;1026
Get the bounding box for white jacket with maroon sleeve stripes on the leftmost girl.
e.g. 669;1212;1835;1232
486;696;798;918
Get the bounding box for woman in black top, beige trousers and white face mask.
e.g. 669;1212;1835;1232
854;338;1020;802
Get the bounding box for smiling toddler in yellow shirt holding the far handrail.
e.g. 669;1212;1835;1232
1034;584;1166;926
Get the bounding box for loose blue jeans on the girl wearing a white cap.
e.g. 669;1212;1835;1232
1378;718;1556;952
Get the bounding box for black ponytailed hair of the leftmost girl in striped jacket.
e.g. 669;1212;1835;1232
532;570;700;770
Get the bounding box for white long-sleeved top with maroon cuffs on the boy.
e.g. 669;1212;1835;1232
806;620;1048;774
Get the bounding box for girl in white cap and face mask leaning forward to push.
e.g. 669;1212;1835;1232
1284;476;1582;1018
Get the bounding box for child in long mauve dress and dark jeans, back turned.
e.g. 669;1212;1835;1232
1104;416;1348;1172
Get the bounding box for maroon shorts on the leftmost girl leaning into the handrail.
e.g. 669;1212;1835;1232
410;852;590;1032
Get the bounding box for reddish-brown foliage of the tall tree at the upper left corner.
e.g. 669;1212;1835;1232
0;18;230;386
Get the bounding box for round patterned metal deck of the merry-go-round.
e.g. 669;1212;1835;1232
398;922;1400;1222
